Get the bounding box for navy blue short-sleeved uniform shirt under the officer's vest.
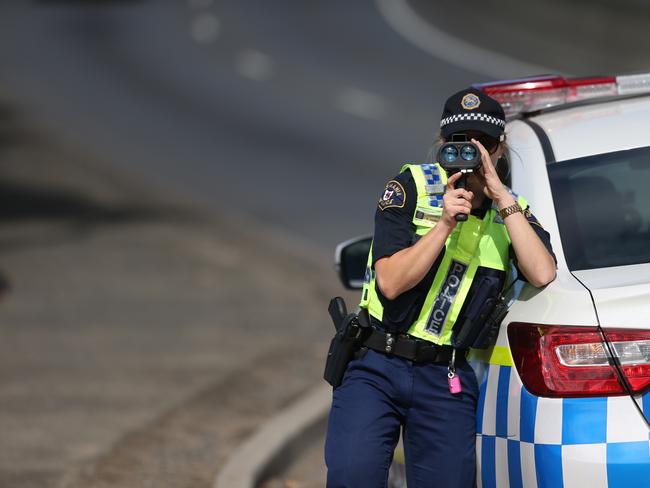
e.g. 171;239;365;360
372;171;557;331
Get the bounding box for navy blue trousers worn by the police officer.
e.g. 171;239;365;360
325;350;478;488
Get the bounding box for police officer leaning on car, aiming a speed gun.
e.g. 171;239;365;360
325;88;556;488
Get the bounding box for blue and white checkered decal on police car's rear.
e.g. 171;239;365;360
476;364;650;488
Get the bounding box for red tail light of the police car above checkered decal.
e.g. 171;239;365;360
508;323;650;397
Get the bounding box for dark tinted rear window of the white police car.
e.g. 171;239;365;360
547;147;650;270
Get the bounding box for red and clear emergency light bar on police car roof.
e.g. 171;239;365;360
474;74;650;118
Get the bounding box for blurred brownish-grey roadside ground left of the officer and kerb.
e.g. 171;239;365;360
0;107;354;488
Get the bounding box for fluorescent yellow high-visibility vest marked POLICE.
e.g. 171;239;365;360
359;164;528;344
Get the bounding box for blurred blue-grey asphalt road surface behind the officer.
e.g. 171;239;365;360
0;0;480;250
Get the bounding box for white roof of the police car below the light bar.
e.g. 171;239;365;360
526;95;650;161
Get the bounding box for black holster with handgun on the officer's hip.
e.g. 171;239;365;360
323;297;370;388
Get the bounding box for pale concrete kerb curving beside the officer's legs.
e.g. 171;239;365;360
213;382;332;488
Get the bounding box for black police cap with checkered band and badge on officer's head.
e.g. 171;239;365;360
440;88;506;139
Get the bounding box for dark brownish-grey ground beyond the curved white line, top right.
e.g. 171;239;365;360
407;0;650;75
